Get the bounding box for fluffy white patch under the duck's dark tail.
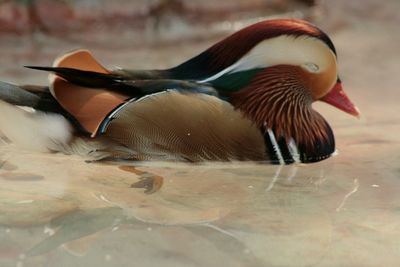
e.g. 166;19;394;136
0;101;73;152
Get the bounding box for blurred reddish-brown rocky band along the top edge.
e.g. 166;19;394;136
0;0;315;34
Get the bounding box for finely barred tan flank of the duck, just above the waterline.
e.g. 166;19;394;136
99;91;267;162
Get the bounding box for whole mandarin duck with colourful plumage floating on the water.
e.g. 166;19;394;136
0;19;359;164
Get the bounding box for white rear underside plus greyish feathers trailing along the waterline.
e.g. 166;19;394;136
0;100;135;161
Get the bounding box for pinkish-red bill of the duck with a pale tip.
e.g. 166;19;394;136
320;82;360;117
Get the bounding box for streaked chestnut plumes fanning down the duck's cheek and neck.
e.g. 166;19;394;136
230;65;329;147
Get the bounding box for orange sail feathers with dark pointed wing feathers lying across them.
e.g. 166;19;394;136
30;50;219;136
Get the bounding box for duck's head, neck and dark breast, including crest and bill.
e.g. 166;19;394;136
170;19;359;163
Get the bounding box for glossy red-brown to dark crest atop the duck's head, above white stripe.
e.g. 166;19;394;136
168;19;336;80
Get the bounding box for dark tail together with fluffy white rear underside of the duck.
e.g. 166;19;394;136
0;82;73;151
